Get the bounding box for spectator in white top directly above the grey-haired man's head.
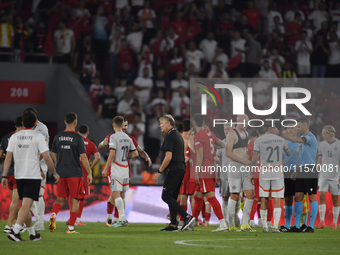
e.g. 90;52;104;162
170;87;190;119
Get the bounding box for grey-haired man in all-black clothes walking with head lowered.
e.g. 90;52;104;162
155;114;195;231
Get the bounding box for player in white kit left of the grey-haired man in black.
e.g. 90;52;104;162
102;116;138;227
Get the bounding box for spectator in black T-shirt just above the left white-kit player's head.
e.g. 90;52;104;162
96;85;118;121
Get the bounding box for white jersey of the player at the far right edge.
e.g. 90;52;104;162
318;139;340;180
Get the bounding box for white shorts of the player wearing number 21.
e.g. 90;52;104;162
259;178;285;198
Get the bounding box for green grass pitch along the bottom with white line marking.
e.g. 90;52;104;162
0;221;340;255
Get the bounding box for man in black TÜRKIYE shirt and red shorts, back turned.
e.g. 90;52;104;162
49;112;92;234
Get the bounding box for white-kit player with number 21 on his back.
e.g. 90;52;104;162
251;126;290;233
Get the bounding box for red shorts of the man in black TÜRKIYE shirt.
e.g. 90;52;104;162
57;176;85;200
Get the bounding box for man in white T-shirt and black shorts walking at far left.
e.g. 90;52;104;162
1;112;59;242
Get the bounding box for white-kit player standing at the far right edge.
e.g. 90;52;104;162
316;125;340;229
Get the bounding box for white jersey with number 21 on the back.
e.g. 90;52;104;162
254;134;288;179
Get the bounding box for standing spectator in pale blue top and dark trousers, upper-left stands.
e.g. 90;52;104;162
92;6;108;72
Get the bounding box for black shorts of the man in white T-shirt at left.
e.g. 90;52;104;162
15;179;41;201
